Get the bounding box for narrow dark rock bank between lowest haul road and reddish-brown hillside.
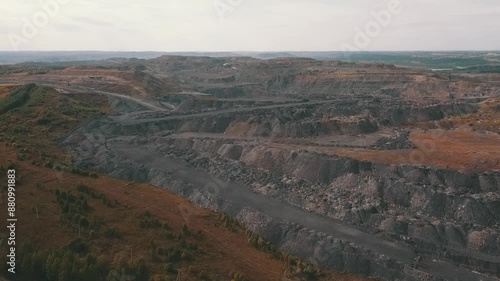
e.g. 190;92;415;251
61;134;438;281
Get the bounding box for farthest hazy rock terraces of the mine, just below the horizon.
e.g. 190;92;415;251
140;57;500;102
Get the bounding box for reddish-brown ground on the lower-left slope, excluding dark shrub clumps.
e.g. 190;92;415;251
0;142;371;281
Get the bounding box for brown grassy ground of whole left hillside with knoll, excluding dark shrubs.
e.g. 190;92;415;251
0;84;376;281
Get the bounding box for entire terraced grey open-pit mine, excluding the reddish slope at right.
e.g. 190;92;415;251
54;57;500;281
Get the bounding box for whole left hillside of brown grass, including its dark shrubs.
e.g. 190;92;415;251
0;84;376;281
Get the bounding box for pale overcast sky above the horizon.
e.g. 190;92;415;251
0;0;500;51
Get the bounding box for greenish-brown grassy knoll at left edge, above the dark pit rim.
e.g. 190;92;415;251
0;83;109;165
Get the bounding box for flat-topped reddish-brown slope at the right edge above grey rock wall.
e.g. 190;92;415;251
336;98;500;172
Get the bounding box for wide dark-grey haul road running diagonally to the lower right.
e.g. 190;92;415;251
108;144;497;281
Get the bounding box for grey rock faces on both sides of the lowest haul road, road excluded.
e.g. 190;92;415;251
61;115;500;280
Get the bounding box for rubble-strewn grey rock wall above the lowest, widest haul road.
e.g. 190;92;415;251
149;136;500;274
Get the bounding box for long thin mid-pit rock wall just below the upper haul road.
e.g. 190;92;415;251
117;102;478;138
